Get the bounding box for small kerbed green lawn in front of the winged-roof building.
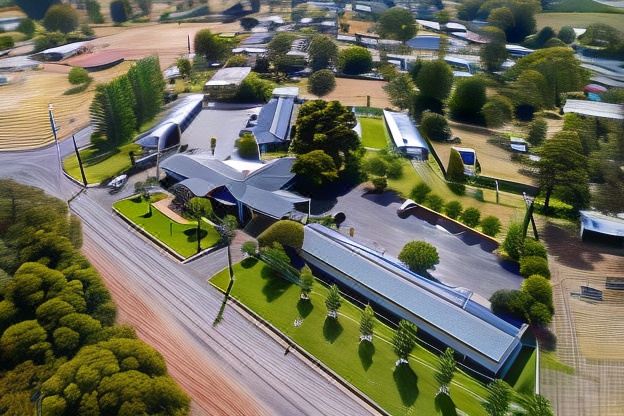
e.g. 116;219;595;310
113;197;219;258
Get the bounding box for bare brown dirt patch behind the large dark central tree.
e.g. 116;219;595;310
298;78;392;108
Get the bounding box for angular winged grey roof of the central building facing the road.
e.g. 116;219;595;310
160;153;308;219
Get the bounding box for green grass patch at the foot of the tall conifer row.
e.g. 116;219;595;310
63;143;141;184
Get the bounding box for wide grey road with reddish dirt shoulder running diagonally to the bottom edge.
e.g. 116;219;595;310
0;131;378;416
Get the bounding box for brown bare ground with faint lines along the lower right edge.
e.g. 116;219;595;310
541;222;624;416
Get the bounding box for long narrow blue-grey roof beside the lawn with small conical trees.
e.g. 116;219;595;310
303;224;523;362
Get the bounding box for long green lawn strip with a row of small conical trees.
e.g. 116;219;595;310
211;259;486;415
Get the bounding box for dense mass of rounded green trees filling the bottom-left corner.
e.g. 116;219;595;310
0;180;189;416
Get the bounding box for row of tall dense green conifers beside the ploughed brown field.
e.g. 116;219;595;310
90;56;165;147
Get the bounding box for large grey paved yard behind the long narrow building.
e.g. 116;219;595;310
324;187;522;300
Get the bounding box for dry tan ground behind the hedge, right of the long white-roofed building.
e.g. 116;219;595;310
433;123;533;184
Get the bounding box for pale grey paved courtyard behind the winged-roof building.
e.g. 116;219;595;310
182;108;259;160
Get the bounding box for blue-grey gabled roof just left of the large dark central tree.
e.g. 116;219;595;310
251;97;295;144
